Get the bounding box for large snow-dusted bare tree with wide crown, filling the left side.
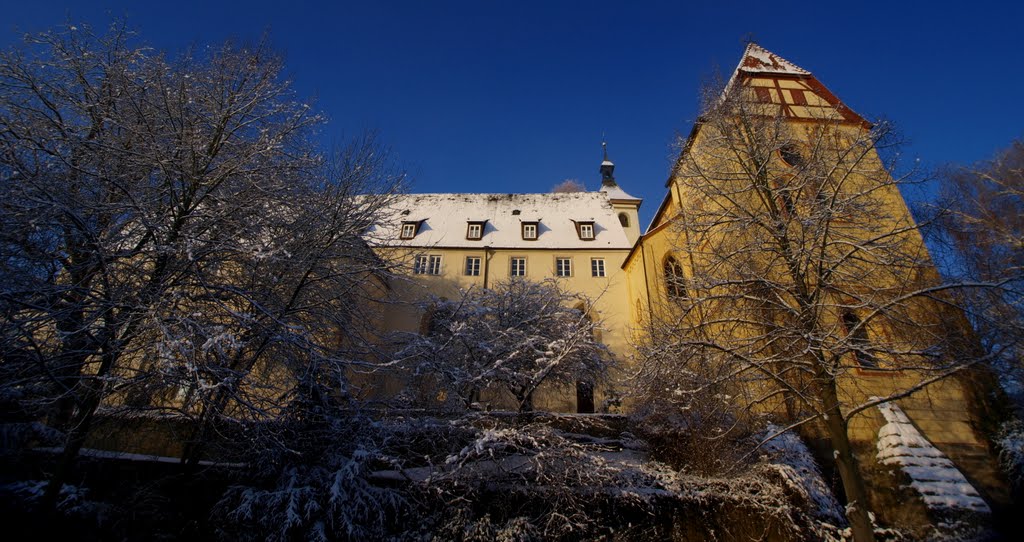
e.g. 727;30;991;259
0;21;397;502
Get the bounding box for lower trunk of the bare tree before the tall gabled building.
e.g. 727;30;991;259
821;381;874;542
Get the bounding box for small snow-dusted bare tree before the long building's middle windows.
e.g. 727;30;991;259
404;280;611;412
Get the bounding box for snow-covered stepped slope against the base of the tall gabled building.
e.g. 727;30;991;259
877;403;991;513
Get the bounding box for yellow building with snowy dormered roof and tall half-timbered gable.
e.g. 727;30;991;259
378;45;999;481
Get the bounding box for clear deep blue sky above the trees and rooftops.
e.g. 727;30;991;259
0;0;1024;221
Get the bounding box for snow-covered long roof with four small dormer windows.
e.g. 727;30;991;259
367;189;636;249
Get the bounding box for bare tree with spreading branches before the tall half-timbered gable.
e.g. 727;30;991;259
640;78;980;541
